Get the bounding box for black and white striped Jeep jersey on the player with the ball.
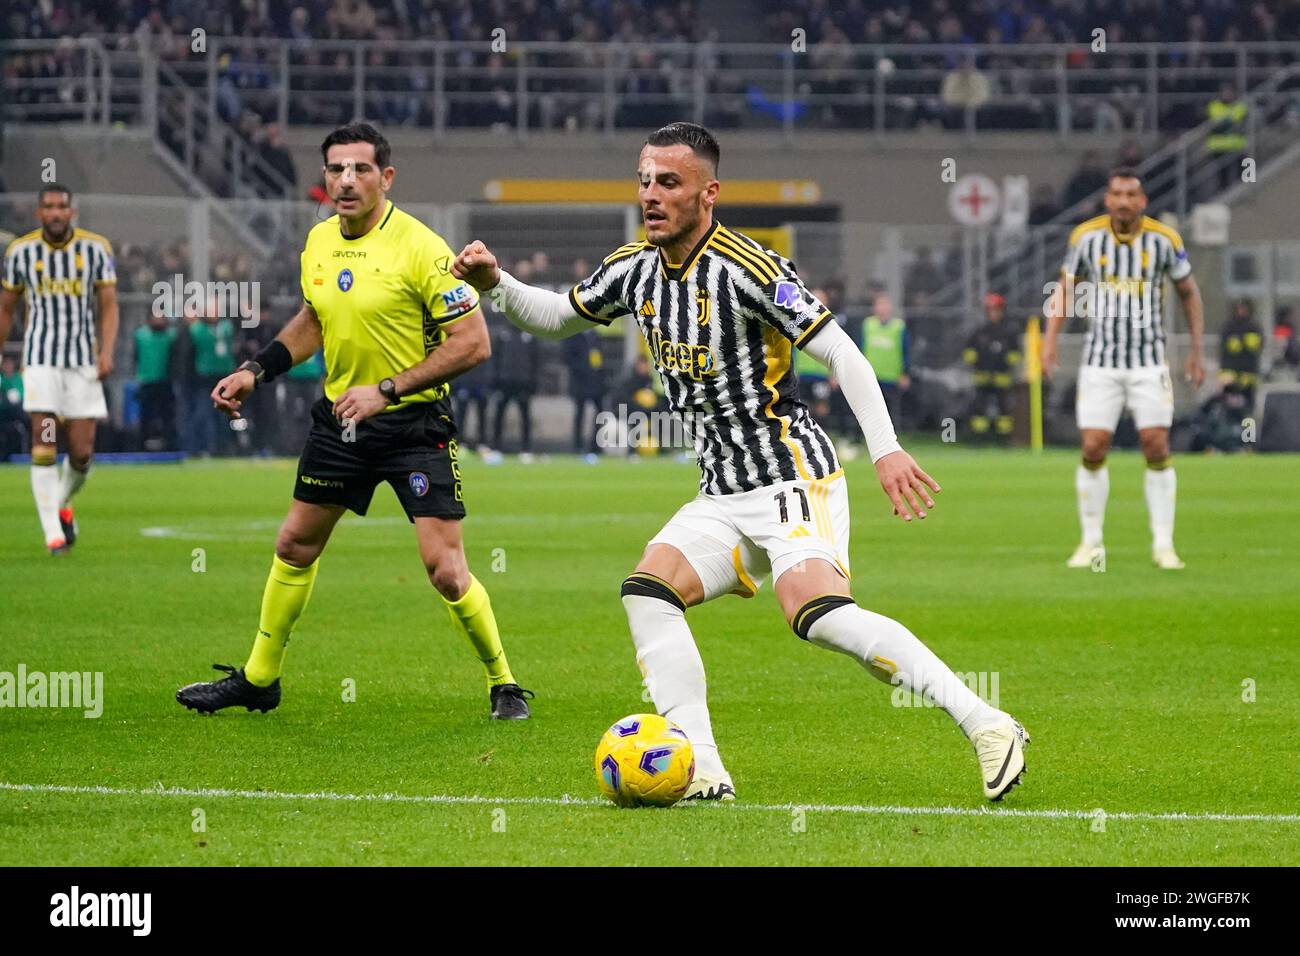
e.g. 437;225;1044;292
569;221;840;494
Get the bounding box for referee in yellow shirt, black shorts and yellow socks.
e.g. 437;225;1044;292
176;122;533;721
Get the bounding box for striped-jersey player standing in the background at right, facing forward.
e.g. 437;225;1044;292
1043;169;1205;571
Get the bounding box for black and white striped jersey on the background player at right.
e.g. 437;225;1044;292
1061;215;1192;368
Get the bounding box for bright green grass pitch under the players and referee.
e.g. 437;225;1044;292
0;445;1300;865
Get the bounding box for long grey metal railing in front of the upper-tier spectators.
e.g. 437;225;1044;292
4;36;1300;139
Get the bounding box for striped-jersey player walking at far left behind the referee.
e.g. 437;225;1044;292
0;183;117;554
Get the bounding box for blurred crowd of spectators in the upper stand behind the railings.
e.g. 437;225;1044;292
5;0;1300;139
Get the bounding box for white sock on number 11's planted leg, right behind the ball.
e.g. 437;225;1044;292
623;594;727;779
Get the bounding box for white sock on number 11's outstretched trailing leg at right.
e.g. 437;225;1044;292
807;604;1006;736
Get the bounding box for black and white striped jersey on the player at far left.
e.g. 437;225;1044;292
0;229;117;368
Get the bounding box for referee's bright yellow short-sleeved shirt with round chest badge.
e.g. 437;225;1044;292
302;202;478;411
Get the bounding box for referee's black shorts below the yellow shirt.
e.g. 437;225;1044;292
294;398;465;522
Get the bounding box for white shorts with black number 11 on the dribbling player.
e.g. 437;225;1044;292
650;472;849;601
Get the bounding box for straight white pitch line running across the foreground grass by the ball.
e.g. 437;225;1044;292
0;782;1300;823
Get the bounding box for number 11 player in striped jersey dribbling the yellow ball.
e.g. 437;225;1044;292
452;122;1028;800
